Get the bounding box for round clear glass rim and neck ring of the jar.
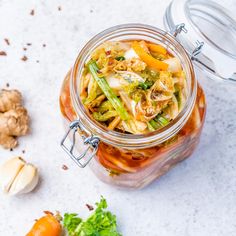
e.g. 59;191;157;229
70;24;197;149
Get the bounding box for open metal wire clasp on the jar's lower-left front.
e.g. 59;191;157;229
61;120;100;168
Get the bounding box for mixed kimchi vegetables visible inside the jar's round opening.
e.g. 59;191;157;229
80;41;187;134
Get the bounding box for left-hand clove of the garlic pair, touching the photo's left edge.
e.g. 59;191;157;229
0;157;25;193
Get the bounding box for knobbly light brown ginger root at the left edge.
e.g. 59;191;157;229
0;89;29;149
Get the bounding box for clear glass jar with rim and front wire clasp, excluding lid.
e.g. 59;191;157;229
60;24;206;188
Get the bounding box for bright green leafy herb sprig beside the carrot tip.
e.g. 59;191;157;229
63;197;121;236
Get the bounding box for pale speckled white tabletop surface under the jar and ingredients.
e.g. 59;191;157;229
0;0;236;236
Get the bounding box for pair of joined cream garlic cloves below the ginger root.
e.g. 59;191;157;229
0;157;39;195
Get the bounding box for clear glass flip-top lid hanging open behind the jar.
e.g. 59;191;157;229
164;0;236;84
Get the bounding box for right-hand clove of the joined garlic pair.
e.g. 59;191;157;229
9;164;39;195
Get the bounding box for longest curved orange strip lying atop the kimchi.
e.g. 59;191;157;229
132;42;168;70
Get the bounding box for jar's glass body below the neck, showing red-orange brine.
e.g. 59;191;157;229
60;72;206;188
